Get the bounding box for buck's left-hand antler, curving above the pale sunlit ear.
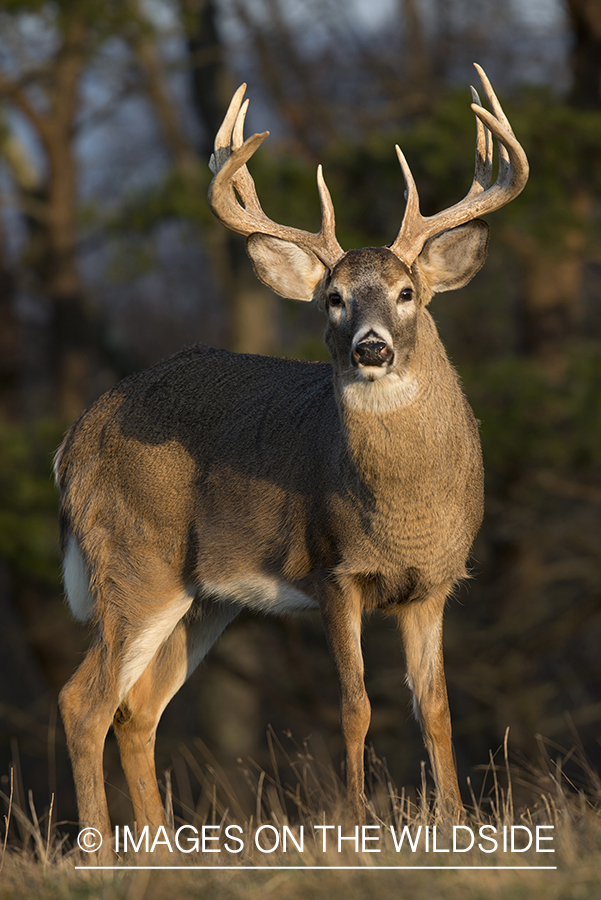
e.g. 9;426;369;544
209;84;344;268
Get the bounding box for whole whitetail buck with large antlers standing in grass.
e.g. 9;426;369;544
56;63;528;844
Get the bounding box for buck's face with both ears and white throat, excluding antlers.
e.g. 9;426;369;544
247;220;488;411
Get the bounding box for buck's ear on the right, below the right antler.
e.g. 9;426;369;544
417;219;488;294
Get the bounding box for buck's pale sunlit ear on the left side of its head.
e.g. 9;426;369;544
246;234;326;301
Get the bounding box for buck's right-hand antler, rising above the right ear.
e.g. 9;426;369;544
390;63;529;266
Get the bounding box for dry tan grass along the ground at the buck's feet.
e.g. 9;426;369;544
0;734;601;900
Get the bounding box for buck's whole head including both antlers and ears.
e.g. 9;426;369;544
209;66;528;406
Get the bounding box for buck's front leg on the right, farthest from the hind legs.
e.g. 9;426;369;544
398;585;463;821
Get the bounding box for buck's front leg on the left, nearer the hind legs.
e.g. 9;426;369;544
320;585;371;824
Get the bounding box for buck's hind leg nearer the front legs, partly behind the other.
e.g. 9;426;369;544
113;599;238;831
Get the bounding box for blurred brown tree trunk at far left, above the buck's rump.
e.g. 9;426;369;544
0;2;112;421
